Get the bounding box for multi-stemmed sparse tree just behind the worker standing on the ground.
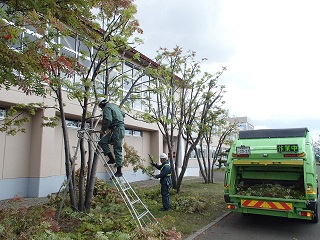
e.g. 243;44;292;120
143;47;225;192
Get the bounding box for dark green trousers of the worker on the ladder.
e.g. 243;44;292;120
99;126;125;167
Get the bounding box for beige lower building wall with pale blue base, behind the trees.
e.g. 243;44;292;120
0;89;163;200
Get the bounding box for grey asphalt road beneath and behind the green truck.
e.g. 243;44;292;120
192;166;320;240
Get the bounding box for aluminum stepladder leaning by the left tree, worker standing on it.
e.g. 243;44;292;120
78;129;158;228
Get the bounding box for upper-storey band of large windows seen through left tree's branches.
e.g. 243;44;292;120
7;18;157;112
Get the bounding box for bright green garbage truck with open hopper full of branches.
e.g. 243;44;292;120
224;128;319;223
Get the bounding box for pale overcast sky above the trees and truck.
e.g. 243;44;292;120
135;0;320;140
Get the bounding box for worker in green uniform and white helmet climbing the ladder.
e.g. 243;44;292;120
98;98;125;177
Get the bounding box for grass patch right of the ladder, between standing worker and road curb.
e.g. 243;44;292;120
137;180;227;238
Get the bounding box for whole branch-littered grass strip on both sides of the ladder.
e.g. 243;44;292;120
0;176;227;240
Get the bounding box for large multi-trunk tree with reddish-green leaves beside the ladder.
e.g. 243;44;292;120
0;0;148;212
